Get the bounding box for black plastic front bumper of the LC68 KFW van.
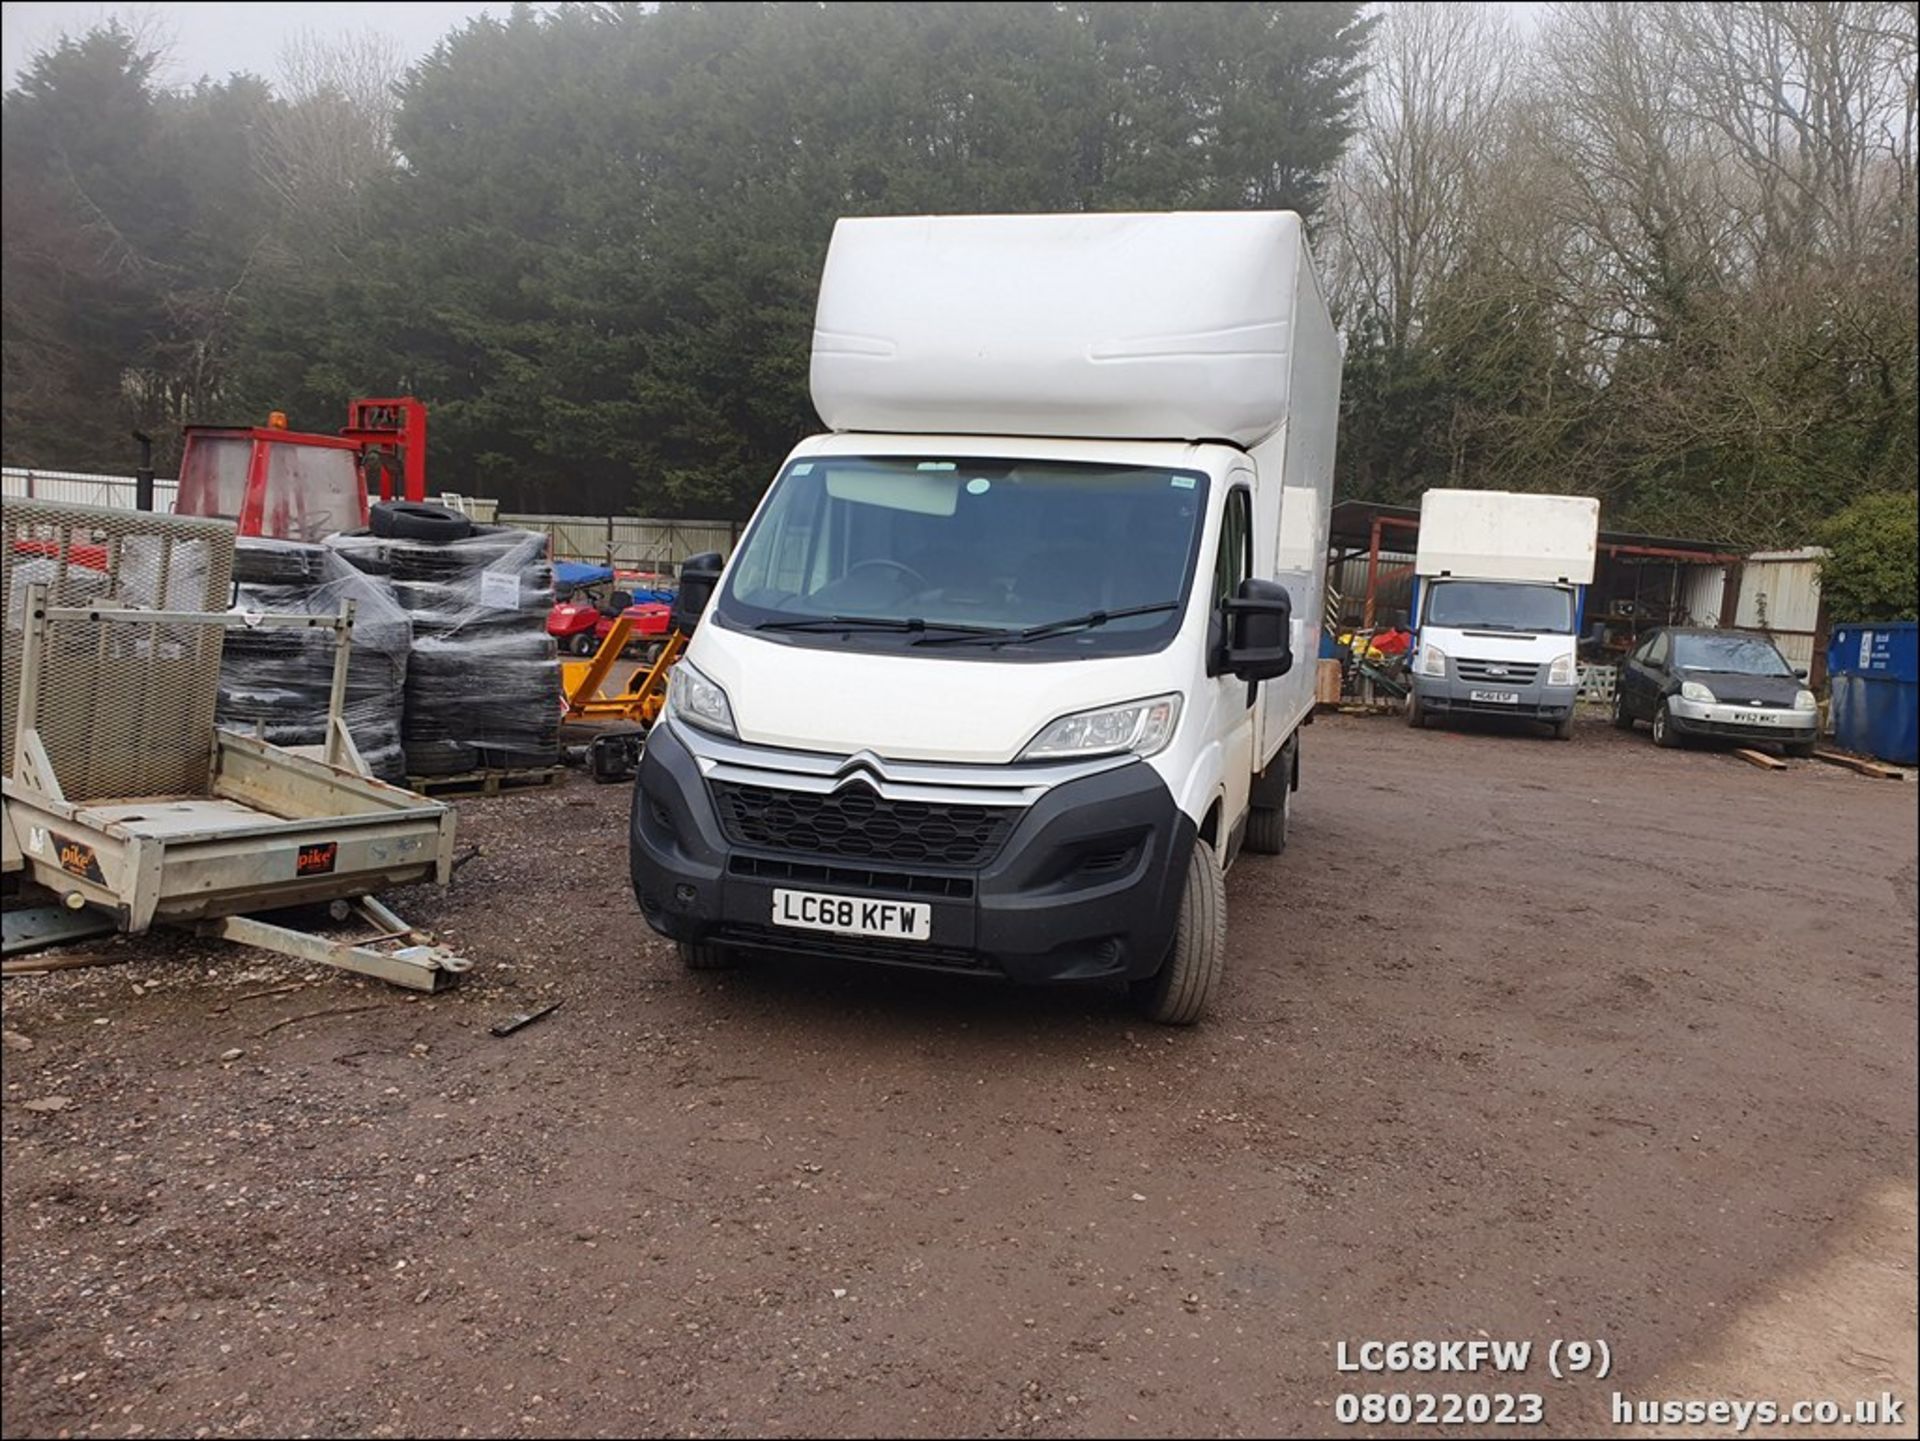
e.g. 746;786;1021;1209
628;725;1194;982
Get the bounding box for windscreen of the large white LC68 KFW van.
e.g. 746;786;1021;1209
714;457;1206;658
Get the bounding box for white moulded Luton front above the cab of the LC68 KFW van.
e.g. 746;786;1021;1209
812;211;1325;449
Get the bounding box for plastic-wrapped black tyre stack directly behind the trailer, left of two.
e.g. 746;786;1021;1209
217;537;411;781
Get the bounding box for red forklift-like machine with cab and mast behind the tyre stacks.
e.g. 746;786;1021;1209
173;395;426;541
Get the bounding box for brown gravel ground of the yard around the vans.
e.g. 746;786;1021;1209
0;716;1920;1435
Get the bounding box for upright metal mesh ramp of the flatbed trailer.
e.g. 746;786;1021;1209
0;499;234;800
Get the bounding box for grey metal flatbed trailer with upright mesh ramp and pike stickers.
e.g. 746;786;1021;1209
0;503;467;990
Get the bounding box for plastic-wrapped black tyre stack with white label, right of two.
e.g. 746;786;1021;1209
328;526;561;775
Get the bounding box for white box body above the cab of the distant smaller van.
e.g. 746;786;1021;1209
1413;491;1599;585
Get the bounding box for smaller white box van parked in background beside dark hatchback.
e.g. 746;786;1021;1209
1407;491;1599;741
